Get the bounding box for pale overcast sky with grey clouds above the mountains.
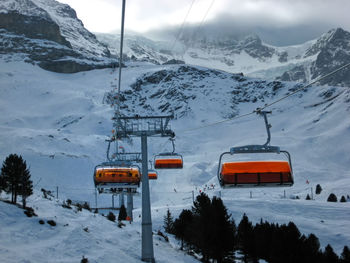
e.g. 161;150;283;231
58;0;350;45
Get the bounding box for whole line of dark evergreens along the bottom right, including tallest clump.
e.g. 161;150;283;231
164;193;350;263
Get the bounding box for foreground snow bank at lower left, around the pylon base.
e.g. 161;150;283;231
0;192;198;263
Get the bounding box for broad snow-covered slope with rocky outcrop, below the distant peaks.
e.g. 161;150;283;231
0;58;350;262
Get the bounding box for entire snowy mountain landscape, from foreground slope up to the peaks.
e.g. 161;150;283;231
0;0;350;262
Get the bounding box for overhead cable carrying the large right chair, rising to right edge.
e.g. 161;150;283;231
181;63;350;132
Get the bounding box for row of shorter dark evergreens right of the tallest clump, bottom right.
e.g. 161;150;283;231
237;215;350;263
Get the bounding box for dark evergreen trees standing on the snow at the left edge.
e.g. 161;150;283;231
0;154;33;208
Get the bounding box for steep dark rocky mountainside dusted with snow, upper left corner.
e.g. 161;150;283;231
0;0;115;72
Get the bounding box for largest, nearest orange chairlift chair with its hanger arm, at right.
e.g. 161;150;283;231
217;109;294;188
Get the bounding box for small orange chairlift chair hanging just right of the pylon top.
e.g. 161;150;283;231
154;138;183;169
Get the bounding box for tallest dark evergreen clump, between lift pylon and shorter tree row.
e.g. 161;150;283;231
173;193;236;262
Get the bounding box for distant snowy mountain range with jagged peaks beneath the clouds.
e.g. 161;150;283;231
97;28;350;86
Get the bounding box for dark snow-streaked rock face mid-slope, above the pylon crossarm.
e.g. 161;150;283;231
105;65;294;118
